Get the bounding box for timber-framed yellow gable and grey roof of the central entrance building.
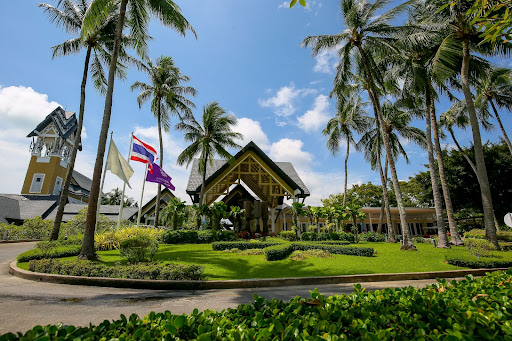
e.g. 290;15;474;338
187;141;310;208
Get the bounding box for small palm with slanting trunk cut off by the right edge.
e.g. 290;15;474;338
475;66;512;155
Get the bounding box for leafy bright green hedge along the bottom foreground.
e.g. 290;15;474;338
4;271;512;341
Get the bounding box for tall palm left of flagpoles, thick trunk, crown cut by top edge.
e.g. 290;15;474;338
78;0;195;259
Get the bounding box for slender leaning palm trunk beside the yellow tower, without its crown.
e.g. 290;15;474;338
50;46;92;241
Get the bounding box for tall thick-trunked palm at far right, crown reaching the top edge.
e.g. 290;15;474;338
424;0;506;250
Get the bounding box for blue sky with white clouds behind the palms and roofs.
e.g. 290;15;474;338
0;0;512;205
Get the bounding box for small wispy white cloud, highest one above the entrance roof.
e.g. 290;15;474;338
258;83;317;117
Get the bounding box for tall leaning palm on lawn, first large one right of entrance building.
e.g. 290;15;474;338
302;0;415;250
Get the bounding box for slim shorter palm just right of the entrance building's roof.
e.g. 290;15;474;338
322;93;371;206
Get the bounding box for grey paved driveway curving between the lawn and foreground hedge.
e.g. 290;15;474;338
0;243;456;335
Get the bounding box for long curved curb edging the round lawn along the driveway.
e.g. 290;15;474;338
9;261;509;290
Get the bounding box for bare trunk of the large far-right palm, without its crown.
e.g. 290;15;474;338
461;38;501;250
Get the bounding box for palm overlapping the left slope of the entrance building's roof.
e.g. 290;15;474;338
176;102;243;206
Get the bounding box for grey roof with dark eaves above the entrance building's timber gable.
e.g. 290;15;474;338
187;141;310;197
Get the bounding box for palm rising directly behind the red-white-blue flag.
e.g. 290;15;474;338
130;56;197;226
